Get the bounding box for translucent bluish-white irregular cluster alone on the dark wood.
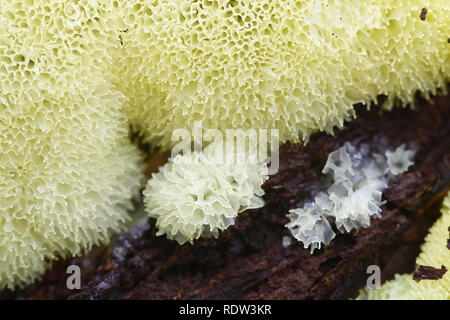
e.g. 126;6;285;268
286;143;415;252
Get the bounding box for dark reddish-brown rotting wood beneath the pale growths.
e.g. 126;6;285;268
0;96;450;299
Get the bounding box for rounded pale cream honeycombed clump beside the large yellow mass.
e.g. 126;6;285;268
144;145;268;244
